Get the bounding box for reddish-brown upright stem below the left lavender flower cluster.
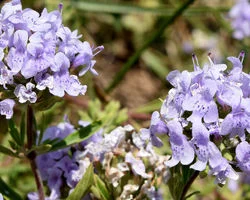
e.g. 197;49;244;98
26;105;45;200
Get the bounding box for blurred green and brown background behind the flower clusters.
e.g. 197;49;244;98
0;0;250;200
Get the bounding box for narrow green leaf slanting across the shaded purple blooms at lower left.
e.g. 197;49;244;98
50;121;101;151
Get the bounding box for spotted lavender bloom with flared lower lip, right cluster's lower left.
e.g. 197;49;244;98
165;120;194;167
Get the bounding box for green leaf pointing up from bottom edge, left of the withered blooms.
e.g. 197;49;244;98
66;164;94;200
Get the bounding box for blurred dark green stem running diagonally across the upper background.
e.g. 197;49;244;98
106;0;194;92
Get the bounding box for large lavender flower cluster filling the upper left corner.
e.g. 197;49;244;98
0;0;103;119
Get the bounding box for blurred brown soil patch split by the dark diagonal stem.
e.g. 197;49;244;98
95;56;162;109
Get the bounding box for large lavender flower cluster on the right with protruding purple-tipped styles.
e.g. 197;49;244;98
149;52;250;184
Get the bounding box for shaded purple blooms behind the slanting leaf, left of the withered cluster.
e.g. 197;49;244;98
36;119;79;199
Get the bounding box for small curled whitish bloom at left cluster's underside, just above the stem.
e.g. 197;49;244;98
14;82;37;103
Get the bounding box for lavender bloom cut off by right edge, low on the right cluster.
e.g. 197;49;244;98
236;141;250;173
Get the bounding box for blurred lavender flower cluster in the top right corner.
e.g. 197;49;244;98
229;0;250;40
